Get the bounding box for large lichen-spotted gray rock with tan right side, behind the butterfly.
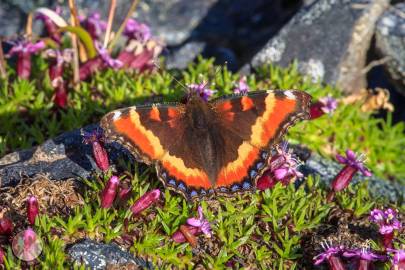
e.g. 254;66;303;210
251;0;389;92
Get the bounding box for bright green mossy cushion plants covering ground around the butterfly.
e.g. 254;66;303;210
0;58;405;269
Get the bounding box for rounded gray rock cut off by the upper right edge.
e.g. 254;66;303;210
375;3;405;96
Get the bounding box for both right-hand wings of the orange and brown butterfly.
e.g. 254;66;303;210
211;90;311;193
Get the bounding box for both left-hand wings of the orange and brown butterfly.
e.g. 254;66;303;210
100;103;211;197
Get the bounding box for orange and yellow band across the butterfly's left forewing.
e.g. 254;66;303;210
114;110;164;159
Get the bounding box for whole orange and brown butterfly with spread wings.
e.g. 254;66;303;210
100;90;311;200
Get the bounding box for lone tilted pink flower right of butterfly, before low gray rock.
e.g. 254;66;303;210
332;150;371;191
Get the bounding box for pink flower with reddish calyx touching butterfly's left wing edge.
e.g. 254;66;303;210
83;129;110;172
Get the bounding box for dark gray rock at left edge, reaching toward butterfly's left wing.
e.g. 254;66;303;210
0;125;126;187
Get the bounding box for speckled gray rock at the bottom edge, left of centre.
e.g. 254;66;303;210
67;239;153;270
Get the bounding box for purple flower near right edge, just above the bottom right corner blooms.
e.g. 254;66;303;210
370;208;402;235
